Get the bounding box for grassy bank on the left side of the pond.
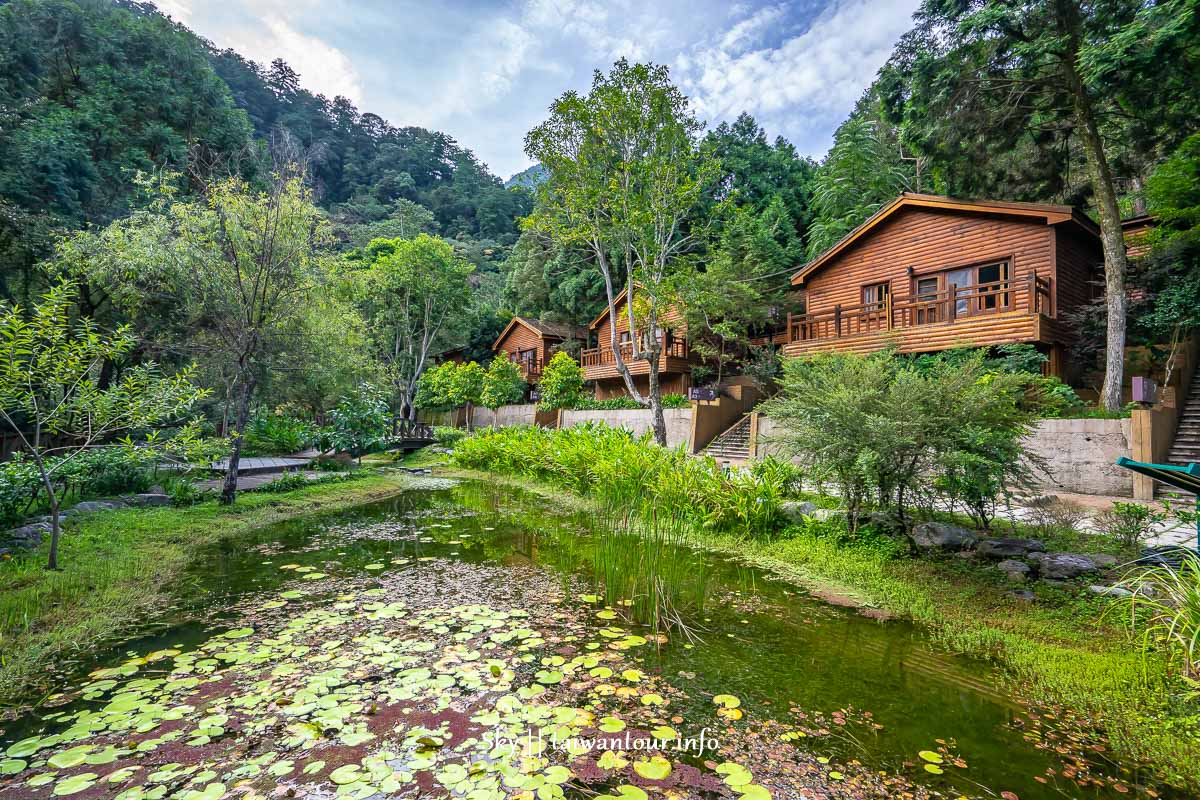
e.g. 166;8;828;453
0;471;420;705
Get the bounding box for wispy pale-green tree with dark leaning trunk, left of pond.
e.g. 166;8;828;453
61;164;332;504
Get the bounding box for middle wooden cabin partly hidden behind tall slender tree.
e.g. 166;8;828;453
580;289;694;399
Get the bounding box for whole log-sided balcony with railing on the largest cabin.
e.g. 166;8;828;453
784;275;1062;356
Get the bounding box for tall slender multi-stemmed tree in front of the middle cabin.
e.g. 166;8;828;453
526;59;715;445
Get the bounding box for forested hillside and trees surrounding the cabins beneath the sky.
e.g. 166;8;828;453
0;0;1200;455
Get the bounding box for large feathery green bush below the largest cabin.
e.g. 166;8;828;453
763;351;1036;528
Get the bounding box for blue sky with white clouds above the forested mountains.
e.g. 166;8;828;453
150;0;918;178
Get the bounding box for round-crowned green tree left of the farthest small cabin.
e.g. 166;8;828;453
347;234;474;420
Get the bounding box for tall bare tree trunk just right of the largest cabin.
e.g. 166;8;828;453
1058;2;1129;411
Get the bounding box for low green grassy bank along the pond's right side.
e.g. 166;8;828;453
442;469;1200;789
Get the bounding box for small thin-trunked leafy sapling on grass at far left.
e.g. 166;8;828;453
0;283;206;570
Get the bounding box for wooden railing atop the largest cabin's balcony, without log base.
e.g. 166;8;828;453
787;275;1054;342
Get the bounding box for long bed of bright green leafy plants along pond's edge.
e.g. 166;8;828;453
454;425;796;539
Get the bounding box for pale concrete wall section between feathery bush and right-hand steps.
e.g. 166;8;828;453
1025;420;1133;497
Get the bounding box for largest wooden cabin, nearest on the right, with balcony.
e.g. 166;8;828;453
782;194;1104;377
